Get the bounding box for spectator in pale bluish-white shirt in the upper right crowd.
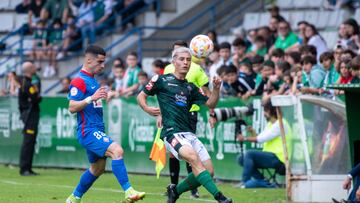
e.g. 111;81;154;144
305;24;327;60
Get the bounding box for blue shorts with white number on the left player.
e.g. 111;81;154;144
78;129;113;163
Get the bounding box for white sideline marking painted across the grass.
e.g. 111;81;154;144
0;180;216;202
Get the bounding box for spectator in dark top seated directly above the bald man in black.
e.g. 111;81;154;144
32;20;47;67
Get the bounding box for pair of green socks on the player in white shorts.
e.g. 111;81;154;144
176;170;220;197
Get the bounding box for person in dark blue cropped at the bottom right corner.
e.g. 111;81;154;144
333;164;360;203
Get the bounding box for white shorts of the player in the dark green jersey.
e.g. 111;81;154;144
164;132;210;162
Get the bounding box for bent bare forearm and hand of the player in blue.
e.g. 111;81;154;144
69;87;107;113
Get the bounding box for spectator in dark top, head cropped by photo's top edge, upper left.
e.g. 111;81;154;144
40;0;69;23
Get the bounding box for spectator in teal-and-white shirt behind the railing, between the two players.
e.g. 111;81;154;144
122;52;141;95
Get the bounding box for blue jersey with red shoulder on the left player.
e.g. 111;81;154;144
68;70;105;136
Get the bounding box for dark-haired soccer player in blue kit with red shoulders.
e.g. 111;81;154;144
66;45;145;203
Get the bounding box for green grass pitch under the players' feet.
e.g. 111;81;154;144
0;165;285;203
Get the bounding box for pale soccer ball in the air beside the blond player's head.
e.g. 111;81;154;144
190;35;214;58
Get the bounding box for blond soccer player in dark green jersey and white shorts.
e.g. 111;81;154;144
137;47;232;203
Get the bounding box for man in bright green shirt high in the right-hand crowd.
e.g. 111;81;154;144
274;21;299;51
